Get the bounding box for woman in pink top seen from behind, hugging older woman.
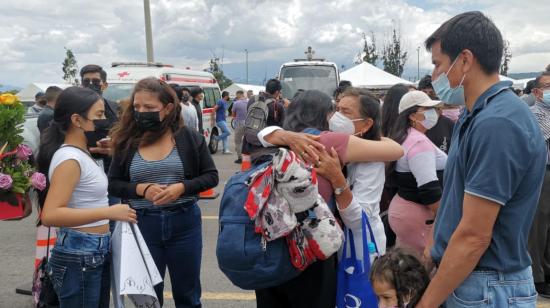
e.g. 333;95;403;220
256;90;403;308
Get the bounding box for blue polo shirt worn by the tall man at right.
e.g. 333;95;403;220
431;81;546;272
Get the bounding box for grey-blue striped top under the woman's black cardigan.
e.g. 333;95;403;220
129;147;197;209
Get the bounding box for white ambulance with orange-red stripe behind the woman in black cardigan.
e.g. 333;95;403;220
103;62;221;154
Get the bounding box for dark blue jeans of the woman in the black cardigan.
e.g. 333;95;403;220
136;203;202;308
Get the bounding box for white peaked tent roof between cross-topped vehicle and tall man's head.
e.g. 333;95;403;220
340;62;413;89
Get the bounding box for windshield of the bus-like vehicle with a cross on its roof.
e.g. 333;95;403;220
279;65;338;98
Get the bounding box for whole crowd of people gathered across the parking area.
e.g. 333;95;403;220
20;12;550;308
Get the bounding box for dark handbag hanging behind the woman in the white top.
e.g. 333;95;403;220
32;227;59;308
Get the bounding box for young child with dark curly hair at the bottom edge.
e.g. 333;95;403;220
370;248;430;308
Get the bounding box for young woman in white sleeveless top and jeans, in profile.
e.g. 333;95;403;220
37;87;136;308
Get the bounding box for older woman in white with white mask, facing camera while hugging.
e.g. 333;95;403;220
317;87;386;261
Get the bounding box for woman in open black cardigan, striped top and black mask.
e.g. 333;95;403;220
109;78;218;307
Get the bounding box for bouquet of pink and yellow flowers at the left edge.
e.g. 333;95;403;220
0;93;46;220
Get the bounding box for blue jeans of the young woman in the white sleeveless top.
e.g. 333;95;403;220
46;228;111;308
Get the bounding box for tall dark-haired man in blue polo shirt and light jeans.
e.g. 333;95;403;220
416;12;546;307
